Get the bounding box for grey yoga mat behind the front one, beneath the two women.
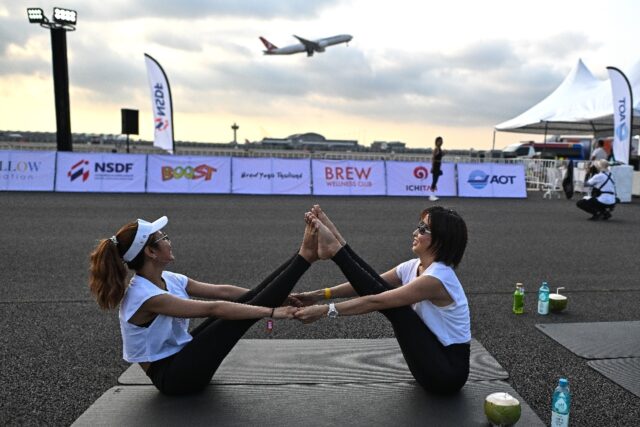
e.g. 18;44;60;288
118;338;509;385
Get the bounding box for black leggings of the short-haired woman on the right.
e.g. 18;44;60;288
332;245;470;394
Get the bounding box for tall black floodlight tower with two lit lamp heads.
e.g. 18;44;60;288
27;7;78;151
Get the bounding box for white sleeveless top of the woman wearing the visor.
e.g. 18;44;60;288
119;271;192;363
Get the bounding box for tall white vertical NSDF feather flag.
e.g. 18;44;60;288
144;53;174;154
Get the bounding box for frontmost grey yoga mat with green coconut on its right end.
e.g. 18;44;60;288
73;381;544;427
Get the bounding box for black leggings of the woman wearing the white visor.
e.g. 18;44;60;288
147;254;310;395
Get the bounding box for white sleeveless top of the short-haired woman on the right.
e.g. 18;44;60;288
396;258;471;346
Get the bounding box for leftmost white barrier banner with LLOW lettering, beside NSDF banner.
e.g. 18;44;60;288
0;151;56;191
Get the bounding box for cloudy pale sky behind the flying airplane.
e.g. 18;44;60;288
0;0;640;149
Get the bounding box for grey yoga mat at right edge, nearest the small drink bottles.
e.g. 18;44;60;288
536;321;640;359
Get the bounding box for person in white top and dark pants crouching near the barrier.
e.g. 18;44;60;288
576;159;616;220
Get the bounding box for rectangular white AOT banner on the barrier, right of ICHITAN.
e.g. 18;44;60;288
458;163;527;198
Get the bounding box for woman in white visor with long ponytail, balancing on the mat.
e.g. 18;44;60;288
89;216;317;395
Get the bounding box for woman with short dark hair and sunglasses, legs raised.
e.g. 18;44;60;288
292;205;471;394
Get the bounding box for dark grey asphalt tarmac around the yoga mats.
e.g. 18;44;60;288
0;192;640;426
